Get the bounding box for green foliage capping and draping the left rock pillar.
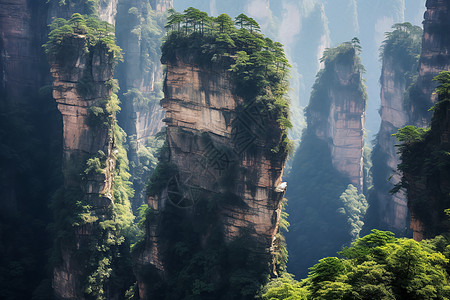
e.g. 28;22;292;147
44;14;136;299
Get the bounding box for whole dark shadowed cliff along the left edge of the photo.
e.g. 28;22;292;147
0;0;61;299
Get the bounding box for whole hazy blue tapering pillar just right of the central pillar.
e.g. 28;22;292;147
286;43;367;276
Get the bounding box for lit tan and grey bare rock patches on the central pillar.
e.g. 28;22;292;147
160;62;286;240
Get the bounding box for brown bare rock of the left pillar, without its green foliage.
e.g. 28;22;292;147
50;35;115;299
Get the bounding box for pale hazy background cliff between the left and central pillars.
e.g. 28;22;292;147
117;0;172;148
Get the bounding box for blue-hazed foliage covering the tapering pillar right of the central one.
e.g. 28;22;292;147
286;40;367;276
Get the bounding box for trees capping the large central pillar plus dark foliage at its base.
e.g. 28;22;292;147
135;8;290;299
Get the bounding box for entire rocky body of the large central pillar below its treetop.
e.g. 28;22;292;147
136;32;287;299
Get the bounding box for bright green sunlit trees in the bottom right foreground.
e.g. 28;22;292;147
262;230;450;300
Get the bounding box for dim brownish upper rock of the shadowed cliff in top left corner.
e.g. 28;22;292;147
0;0;46;103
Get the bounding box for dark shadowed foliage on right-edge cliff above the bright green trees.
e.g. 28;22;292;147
393;72;450;237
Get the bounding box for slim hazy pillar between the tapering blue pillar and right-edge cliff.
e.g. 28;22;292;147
367;23;422;236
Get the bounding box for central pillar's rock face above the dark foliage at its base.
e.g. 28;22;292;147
138;58;286;299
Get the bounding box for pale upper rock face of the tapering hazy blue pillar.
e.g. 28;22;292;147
308;50;366;191
